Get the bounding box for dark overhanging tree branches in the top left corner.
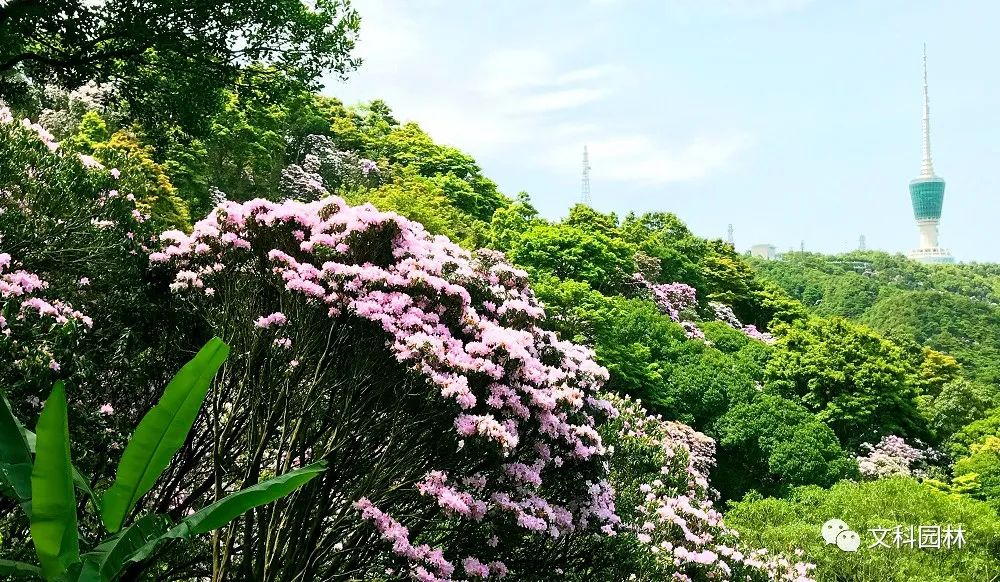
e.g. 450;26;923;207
0;0;360;133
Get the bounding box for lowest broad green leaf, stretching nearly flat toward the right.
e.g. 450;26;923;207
120;461;326;562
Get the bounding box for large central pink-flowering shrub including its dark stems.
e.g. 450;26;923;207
150;197;619;580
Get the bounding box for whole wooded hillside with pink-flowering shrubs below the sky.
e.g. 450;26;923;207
0;3;1000;581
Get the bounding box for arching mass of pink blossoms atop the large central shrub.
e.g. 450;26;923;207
150;197;619;580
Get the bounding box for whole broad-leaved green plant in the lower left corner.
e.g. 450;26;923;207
0;338;325;582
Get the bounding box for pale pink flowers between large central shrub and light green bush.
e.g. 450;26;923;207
611;397;815;582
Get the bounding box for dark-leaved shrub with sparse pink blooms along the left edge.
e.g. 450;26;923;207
0;105;209;572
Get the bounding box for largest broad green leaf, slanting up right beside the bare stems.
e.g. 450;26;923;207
101;337;229;533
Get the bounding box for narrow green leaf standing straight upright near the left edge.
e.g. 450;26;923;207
31;382;80;578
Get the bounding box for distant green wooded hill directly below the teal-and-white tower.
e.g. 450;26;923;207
754;251;1000;392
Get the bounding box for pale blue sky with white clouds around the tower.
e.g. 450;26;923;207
325;0;1000;261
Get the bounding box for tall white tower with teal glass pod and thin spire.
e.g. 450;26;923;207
910;46;955;263
